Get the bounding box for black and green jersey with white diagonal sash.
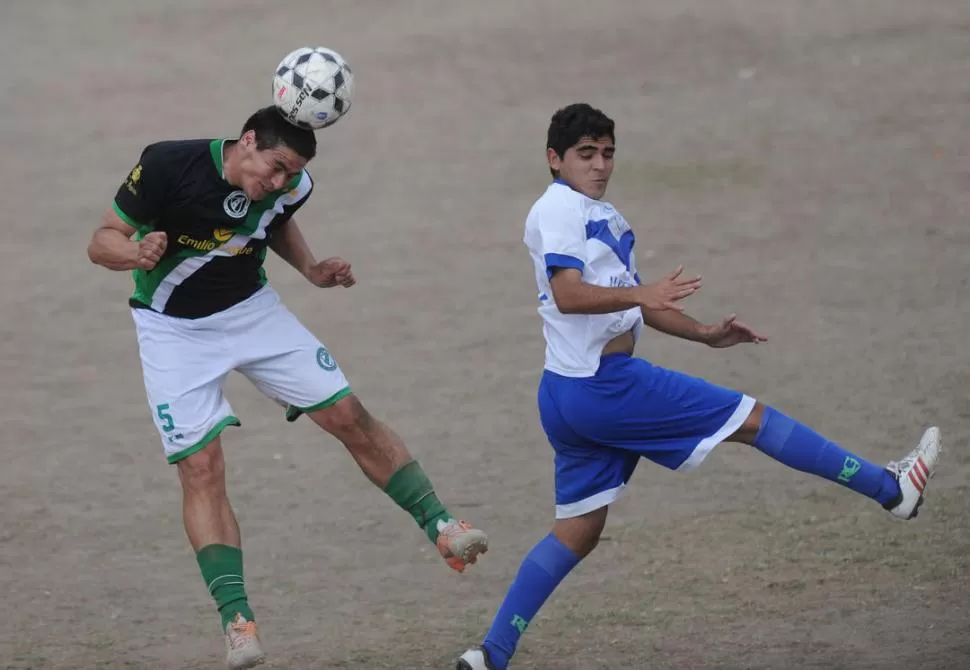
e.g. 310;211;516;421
114;139;313;319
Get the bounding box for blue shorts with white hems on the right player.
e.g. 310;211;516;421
539;354;755;519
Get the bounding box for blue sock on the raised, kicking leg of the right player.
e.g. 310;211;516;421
754;407;899;505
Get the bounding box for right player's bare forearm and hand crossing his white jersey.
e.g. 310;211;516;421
549;266;702;314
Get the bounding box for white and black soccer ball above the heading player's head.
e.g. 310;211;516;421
273;47;354;130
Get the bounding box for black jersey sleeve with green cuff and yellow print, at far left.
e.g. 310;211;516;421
112;146;171;233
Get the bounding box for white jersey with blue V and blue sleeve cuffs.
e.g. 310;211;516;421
524;179;643;377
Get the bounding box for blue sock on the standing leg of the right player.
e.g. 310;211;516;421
482;533;579;670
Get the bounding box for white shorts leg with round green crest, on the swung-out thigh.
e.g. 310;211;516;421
237;305;351;413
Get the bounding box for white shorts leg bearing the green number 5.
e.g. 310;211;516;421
133;309;239;463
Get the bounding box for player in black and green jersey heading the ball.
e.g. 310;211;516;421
88;107;488;668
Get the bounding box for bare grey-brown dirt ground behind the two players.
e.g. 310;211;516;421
0;0;970;670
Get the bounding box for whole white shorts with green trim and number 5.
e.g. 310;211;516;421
132;286;350;463
